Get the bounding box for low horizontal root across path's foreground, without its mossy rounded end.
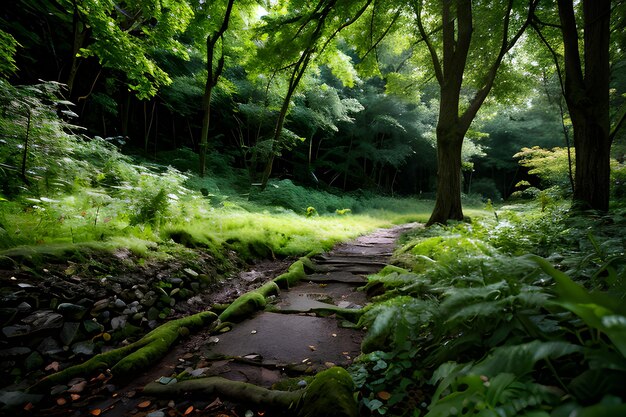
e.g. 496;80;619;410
143;376;302;410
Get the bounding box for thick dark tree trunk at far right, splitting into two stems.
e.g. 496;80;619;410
558;0;611;211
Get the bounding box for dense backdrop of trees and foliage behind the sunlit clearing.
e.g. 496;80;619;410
2;1;626;206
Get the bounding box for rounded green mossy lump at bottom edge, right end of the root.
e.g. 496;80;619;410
297;366;359;417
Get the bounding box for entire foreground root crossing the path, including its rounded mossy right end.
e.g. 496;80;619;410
143;367;358;417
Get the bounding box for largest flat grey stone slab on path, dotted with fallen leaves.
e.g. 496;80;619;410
204;312;363;368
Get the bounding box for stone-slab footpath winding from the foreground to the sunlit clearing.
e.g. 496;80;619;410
51;224;416;417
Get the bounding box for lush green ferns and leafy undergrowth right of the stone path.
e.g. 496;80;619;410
352;204;626;417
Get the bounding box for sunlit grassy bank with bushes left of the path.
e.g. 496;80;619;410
0;80;431;261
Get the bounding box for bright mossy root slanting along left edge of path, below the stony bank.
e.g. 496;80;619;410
29;311;217;392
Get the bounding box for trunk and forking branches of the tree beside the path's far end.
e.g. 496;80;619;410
422;0;538;225
